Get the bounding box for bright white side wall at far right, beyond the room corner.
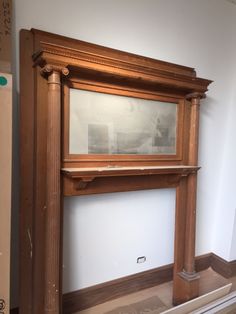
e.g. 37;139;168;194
213;63;236;260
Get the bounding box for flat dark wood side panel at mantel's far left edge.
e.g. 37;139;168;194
18;31;35;314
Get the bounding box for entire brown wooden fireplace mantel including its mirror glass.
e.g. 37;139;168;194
20;30;211;314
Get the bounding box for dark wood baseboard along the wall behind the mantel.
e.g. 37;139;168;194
63;253;211;314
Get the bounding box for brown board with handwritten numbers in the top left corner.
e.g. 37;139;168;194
0;0;12;73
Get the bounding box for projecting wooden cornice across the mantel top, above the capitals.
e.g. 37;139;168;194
33;41;211;94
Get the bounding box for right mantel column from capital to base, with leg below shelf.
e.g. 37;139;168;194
173;93;204;305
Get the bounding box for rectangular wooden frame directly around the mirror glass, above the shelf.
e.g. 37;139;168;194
62;81;183;163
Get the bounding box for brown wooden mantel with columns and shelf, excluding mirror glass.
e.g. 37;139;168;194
20;30;211;314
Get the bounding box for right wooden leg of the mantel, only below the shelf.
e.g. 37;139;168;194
173;175;200;305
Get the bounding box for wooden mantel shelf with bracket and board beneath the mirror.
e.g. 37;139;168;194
61;165;200;196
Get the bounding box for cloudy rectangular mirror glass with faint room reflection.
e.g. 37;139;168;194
69;89;177;155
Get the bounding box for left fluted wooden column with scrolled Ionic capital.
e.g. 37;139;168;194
42;65;69;314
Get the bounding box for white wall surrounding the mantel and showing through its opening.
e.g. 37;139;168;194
15;0;236;291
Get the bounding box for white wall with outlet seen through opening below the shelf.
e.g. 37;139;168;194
63;190;175;292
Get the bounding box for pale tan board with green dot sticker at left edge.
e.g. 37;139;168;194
0;72;12;314
